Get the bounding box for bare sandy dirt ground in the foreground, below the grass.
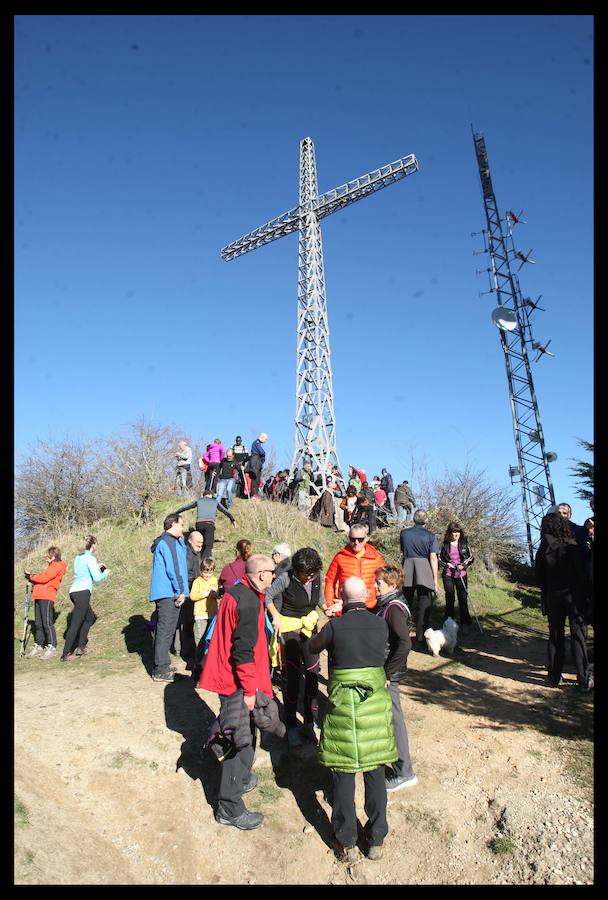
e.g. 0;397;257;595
15;627;593;884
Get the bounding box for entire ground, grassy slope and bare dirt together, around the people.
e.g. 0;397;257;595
14;499;594;886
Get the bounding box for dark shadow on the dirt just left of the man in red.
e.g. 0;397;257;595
164;675;221;809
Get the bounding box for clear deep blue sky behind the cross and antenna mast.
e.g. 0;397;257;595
15;16;594;521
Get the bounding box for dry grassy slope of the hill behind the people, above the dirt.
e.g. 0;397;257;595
14;498;544;669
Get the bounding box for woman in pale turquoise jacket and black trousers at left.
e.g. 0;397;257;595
61;534;110;662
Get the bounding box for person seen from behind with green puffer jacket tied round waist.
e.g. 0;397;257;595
308;577;397;862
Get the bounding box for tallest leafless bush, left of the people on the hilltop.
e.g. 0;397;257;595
97;417;178;524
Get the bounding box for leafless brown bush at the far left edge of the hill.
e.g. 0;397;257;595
15;440;107;545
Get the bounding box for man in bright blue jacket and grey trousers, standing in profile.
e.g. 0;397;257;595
150;513;190;682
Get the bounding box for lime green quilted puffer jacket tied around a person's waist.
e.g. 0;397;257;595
319;667;397;772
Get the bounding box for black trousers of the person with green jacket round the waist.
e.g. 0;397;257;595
331;766;388;847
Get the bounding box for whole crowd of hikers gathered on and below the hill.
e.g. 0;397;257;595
25;433;594;861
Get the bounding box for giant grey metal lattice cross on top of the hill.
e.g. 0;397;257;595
221;137;418;496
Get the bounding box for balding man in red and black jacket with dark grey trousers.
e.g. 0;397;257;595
199;553;275;831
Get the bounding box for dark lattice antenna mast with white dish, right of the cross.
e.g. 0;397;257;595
473;131;557;565
